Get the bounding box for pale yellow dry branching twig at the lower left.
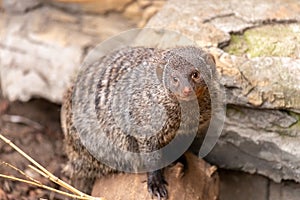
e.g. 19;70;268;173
0;134;105;200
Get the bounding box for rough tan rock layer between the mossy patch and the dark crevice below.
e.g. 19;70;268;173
221;56;300;111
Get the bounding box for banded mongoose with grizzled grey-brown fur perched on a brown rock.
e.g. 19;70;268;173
62;46;215;199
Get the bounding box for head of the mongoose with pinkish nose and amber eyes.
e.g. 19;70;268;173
159;47;214;101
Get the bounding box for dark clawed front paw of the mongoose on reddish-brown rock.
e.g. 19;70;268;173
147;170;168;200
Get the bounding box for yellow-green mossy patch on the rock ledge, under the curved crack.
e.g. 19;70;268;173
224;24;300;57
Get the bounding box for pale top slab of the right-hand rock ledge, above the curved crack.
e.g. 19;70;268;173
147;0;300;47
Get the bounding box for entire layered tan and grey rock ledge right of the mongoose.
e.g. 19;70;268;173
146;0;300;182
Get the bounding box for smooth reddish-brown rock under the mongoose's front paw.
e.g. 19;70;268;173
92;153;219;200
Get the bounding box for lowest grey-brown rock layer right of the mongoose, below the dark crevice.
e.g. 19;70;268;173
206;107;300;182
